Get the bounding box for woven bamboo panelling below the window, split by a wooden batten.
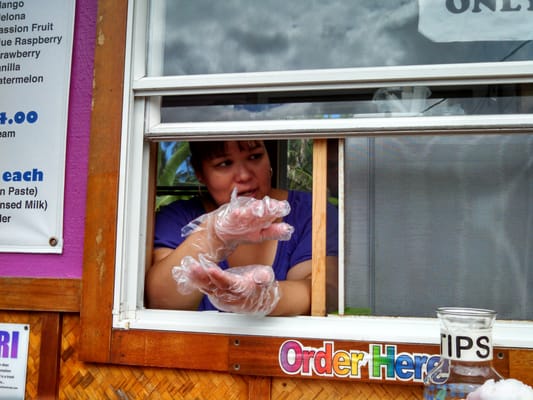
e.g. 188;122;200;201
59;314;421;400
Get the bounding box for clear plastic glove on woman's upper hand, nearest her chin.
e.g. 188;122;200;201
181;189;294;261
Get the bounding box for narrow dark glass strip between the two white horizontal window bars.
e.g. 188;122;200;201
161;84;533;122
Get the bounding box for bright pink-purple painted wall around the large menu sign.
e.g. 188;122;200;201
0;0;97;278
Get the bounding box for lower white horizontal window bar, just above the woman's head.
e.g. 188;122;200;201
145;114;533;140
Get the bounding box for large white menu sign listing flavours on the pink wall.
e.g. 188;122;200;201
0;0;75;253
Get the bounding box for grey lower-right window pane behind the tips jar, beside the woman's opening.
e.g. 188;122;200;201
345;135;533;320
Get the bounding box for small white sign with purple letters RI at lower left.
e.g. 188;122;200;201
0;324;30;400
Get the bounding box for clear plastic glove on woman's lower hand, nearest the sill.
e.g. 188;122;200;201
172;255;280;316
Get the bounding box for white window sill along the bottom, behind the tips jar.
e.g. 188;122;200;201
111;309;533;349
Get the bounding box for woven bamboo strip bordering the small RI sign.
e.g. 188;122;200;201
0;311;42;400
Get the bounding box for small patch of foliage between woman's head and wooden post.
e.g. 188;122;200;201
287;139;313;191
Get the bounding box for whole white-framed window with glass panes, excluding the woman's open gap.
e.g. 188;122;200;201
108;1;533;347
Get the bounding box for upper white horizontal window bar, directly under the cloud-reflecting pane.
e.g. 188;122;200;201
132;61;533;97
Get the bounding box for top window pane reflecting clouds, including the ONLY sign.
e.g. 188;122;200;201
148;0;533;75
